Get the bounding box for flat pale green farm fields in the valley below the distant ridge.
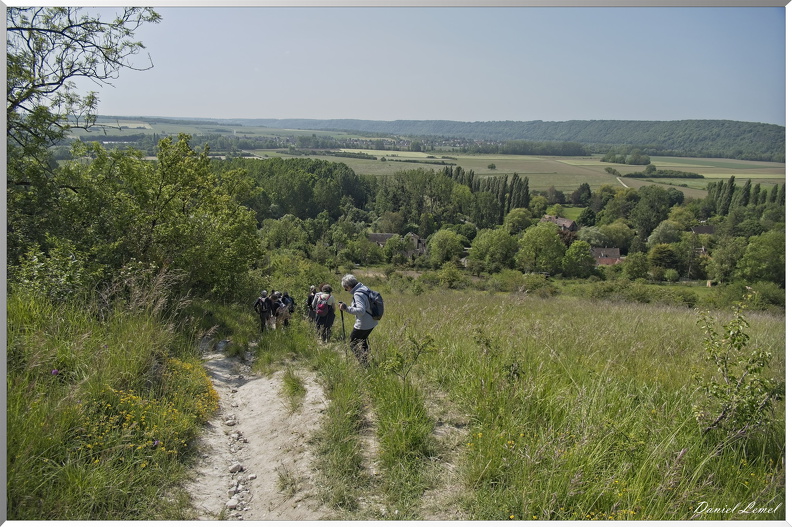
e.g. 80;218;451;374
74;118;786;198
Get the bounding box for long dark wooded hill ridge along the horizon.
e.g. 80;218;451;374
108;119;786;162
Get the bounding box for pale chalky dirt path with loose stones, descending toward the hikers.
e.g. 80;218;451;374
187;342;331;521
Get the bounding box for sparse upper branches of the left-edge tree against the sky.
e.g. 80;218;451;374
6;7;160;155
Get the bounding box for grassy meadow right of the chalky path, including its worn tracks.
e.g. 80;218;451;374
248;281;786;521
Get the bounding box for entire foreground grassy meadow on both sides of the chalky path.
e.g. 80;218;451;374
7;274;786;520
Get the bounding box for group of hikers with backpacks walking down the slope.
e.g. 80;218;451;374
253;274;384;366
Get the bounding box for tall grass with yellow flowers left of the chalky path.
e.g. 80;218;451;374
7;293;218;520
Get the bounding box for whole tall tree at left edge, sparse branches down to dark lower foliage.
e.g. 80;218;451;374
6;7;159;262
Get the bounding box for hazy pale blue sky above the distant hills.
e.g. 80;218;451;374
74;7;786;124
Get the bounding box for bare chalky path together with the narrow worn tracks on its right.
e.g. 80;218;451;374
187;341;465;521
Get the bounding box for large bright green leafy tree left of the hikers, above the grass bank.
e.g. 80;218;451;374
53;135;261;295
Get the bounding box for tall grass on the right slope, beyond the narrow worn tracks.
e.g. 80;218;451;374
373;291;785;520
